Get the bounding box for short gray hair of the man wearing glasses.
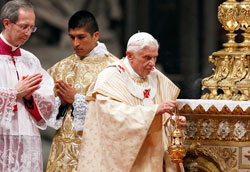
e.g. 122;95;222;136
0;0;35;28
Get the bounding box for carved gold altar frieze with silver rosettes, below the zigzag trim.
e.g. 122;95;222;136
181;114;250;142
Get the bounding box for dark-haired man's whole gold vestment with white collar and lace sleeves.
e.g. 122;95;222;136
47;42;117;172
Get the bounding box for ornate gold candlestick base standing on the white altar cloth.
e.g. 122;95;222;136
201;0;250;101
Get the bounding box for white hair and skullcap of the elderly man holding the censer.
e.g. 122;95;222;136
127;32;159;53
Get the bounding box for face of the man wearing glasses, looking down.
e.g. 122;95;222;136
3;8;36;47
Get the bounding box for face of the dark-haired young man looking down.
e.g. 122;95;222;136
69;27;99;58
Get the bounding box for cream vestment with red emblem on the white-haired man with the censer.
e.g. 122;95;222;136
78;58;185;172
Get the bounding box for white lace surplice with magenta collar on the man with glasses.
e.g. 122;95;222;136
0;34;54;172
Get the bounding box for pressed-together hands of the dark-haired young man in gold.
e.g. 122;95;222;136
56;80;76;106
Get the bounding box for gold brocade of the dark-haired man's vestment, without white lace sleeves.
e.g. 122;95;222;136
47;53;118;172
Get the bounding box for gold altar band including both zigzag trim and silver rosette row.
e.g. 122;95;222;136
180;104;250;142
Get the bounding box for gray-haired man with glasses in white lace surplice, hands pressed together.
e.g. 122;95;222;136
0;0;54;172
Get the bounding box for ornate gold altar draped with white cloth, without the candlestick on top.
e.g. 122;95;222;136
177;99;250;172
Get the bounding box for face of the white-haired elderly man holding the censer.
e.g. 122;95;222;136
126;47;158;77
